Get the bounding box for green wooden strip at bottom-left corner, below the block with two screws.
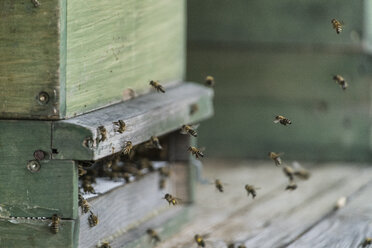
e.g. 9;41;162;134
0;219;79;248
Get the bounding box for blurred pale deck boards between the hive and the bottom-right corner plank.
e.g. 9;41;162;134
162;163;371;248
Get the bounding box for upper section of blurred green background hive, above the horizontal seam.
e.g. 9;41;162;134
188;0;364;45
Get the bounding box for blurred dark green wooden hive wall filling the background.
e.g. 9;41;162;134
187;0;372;161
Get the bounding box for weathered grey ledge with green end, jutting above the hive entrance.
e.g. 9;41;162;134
52;84;213;160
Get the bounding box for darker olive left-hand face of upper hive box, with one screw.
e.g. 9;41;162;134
0;0;63;119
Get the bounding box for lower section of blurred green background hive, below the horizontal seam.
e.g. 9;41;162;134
188;46;371;161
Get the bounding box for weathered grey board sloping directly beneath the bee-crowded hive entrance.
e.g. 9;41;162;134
79;165;188;248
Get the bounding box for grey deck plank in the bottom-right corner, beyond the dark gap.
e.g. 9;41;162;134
288;182;372;248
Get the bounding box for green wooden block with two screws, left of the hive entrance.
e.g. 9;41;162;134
0;120;78;218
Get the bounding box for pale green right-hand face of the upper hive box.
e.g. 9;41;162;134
66;0;185;117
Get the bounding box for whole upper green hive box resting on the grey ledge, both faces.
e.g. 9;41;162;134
0;0;185;119
